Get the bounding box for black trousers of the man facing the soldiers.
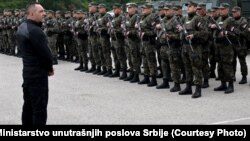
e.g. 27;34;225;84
22;78;49;125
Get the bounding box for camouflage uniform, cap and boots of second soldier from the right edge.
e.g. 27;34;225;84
214;3;235;93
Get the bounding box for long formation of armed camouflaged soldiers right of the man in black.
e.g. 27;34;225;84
0;1;250;98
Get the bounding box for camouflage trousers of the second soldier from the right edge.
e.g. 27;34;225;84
216;42;234;82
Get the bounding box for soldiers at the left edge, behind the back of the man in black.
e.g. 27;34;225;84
0;9;25;55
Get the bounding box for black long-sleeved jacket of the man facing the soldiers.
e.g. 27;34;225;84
16;20;53;79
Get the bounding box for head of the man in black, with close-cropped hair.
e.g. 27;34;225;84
26;3;46;23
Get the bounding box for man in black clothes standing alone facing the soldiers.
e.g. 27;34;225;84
16;3;54;125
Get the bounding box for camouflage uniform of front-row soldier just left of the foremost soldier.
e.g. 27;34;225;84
157;5;181;92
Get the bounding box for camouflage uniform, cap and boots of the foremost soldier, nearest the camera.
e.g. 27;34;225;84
179;1;207;98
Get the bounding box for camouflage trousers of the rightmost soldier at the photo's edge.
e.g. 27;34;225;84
233;44;248;76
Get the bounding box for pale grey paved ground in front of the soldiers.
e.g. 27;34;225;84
0;54;250;124
